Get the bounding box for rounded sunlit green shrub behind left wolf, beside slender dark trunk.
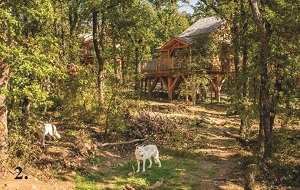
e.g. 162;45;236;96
54;66;100;123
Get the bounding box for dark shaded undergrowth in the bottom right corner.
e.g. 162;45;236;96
246;128;300;188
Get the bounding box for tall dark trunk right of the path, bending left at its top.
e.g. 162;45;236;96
249;0;272;158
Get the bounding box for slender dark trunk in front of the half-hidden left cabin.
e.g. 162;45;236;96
93;11;104;104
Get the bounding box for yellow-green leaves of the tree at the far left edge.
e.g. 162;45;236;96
5;1;66;120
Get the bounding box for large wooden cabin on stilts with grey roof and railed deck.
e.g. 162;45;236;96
140;17;232;104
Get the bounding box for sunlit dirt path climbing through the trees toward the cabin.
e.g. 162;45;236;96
167;108;248;190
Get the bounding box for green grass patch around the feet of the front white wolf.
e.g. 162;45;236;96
76;149;215;190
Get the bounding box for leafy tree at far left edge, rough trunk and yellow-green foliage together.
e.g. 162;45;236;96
0;0;67;164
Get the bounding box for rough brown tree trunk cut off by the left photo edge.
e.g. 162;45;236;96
0;61;9;172
